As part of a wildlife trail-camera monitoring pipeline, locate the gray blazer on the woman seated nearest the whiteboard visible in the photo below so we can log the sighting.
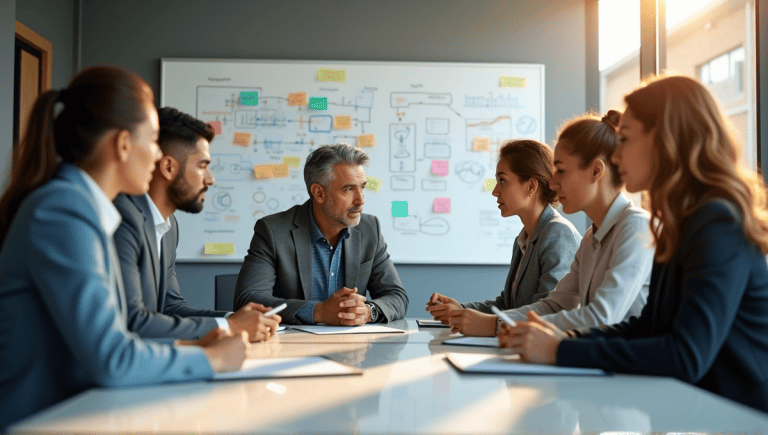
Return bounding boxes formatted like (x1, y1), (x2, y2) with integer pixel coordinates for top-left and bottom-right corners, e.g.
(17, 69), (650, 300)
(462, 205), (581, 314)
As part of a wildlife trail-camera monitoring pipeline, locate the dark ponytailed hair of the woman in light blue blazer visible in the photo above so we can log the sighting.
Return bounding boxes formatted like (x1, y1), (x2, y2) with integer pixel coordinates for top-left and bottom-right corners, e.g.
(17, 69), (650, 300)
(0, 66), (154, 246)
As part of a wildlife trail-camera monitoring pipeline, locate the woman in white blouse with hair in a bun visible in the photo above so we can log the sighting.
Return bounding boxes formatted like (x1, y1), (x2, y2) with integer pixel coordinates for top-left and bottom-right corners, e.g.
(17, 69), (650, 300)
(450, 110), (653, 335)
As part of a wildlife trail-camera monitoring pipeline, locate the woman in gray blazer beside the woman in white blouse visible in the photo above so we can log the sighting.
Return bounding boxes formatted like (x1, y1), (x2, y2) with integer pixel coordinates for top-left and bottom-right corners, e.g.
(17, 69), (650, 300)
(426, 140), (581, 336)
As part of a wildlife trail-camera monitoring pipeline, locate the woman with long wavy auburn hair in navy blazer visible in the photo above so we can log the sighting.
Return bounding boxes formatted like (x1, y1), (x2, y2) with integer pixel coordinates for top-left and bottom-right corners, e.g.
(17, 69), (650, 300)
(499, 76), (768, 412)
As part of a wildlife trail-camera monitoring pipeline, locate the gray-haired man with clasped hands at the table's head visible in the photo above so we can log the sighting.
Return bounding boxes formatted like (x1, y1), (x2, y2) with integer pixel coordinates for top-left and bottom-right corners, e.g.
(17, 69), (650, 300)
(234, 144), (408, 326)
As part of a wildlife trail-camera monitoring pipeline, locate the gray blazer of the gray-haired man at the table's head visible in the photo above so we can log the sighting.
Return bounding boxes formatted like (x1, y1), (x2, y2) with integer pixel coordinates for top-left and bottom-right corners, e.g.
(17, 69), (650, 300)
(234, 199), (408, 323)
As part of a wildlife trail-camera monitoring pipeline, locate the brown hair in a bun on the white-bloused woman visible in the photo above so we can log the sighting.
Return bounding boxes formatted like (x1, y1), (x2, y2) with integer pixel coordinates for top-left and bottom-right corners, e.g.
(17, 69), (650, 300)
(557, 110), (624, 187)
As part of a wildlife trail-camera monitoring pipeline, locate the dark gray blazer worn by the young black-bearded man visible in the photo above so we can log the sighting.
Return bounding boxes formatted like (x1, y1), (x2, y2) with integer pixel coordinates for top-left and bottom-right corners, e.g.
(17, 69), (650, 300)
(114, 195), (227, 339)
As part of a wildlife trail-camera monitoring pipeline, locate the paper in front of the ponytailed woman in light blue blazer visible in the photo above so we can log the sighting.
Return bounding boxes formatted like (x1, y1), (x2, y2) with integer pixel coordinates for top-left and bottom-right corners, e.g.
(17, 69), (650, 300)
(213, 356), (363, 381)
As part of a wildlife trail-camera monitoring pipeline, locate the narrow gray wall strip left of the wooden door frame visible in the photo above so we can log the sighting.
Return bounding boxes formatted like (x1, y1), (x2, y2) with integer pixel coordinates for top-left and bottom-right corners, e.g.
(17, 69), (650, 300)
(0, 0), (16, 192)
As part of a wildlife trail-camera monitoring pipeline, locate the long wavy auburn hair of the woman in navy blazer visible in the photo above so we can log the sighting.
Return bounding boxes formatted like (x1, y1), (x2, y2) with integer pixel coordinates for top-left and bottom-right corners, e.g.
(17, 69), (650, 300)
(624, 75), (768, 262)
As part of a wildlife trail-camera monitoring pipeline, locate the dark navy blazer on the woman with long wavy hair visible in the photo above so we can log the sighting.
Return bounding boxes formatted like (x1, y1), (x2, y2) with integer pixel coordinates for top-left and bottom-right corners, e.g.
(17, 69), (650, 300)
(557, 199), (768, 412)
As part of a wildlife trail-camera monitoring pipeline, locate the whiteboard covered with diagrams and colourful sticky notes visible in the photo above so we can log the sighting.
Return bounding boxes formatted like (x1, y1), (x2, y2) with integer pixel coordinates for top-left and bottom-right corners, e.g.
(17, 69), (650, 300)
(160, 58), (544, 264)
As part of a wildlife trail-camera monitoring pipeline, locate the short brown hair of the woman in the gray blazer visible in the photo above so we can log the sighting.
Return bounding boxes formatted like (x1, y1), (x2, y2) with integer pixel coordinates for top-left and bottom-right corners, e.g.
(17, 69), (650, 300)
(499, 139), (557, 204)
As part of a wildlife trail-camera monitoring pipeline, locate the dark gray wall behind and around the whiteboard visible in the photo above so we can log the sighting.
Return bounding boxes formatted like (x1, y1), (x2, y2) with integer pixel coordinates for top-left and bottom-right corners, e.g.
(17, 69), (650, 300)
(81, 0), (586, 316)
